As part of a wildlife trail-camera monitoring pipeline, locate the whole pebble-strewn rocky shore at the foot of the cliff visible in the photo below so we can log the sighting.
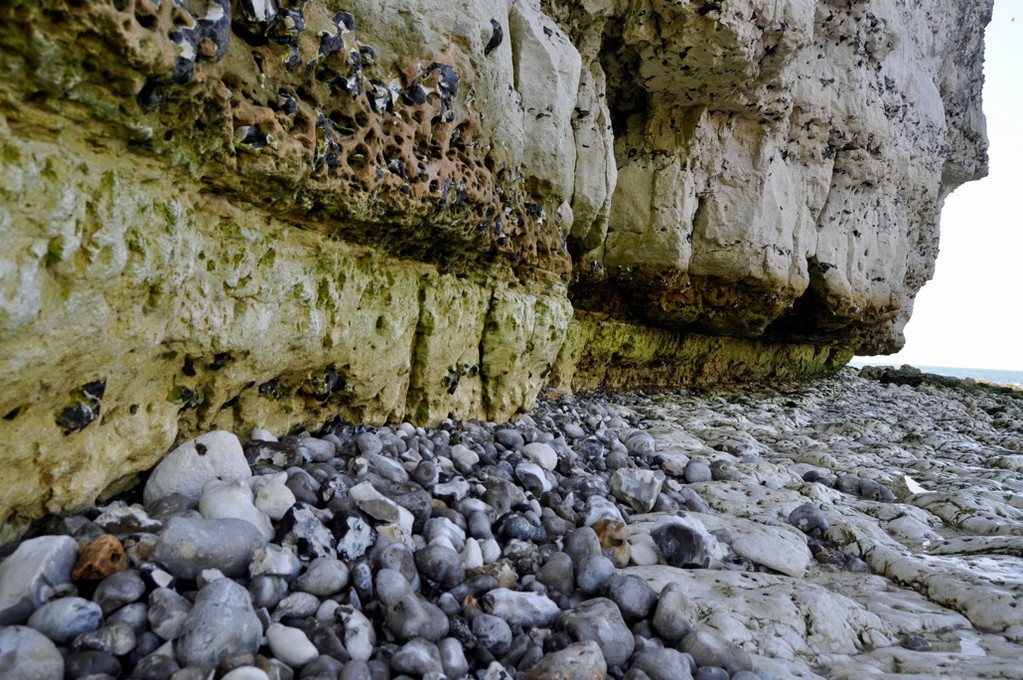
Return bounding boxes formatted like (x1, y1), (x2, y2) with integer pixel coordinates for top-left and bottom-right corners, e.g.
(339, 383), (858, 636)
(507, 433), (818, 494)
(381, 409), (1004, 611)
(0, 369), (1023, 680)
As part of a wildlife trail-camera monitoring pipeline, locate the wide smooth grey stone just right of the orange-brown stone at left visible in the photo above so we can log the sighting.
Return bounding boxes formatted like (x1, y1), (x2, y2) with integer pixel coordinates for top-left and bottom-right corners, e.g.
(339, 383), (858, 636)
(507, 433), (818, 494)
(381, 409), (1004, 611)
(151, 517), (265, 580)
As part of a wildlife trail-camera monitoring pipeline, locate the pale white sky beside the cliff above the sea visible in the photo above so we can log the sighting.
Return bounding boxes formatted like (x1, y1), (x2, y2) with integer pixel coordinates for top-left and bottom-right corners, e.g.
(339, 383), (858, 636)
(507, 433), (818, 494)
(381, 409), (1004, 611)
(857, 0), (1023, 370)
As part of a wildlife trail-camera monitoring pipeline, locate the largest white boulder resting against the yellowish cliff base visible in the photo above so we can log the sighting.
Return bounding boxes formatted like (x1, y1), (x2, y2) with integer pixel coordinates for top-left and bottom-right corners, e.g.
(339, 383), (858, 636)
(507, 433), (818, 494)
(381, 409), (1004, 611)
(142, 429), (251, 507)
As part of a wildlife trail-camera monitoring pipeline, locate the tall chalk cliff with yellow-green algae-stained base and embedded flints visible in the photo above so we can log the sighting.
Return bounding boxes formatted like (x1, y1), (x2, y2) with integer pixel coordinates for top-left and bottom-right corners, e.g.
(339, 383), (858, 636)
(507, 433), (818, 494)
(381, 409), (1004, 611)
(0, 0), (991, 539)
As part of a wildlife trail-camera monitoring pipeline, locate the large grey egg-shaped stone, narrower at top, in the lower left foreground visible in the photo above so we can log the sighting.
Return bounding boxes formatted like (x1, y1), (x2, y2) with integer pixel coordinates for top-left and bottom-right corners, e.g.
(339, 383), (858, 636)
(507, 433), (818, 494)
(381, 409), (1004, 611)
(174, 579), (263, 668)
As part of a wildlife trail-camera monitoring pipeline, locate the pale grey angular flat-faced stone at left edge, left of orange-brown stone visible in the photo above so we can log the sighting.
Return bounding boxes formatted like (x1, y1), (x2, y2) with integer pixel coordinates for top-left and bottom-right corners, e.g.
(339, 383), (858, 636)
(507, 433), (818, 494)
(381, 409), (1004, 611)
(0, 536), (78, 625)
